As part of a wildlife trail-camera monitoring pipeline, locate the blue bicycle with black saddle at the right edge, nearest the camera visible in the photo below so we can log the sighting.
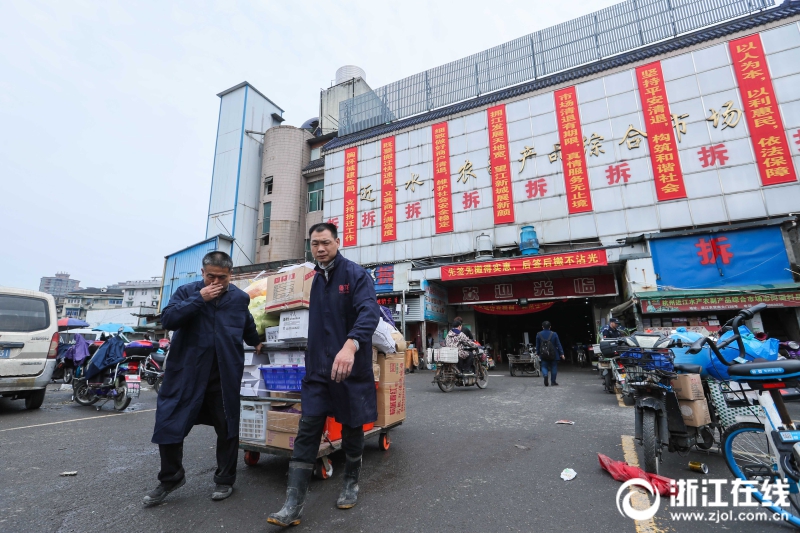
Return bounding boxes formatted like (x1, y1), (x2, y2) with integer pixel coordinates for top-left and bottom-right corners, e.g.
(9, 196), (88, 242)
(688, 304), (800, 528)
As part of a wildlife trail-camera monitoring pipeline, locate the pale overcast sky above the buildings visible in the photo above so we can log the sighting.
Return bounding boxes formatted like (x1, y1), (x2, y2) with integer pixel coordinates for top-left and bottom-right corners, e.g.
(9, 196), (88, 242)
(0, 0), (616, 289)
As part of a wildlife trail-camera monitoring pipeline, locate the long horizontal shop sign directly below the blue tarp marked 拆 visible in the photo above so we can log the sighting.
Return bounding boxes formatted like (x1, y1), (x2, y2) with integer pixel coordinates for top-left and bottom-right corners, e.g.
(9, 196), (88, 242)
(636, 283), (800, 314)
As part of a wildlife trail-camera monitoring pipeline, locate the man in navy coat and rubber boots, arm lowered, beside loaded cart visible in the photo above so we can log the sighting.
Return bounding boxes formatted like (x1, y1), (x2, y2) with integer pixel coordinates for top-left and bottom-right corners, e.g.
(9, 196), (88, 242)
(267, 223), (380, 527)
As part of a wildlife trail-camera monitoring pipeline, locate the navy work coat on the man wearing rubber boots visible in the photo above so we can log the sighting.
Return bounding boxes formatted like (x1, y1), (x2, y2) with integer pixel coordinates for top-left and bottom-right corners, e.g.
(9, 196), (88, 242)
(302, 254), (380, 427)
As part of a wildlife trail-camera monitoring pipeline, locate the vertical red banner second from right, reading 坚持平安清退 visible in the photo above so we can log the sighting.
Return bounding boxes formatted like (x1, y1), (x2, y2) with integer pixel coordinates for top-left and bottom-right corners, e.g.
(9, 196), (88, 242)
(636, 61), (686, 202)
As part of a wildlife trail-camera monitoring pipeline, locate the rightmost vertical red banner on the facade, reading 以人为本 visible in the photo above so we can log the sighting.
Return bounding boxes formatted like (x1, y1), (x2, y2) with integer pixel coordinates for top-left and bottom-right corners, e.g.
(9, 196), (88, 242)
(728, 34), (797, 186)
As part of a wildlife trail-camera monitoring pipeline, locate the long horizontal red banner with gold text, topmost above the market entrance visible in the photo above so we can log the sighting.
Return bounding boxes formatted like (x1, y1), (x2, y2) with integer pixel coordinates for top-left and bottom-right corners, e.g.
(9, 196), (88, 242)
(442, 250), (608, 281)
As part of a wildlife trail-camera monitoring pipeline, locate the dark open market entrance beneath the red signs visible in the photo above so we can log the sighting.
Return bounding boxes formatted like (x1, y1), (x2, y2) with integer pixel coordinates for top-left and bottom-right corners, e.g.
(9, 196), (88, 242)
(475, 298), (596, 361)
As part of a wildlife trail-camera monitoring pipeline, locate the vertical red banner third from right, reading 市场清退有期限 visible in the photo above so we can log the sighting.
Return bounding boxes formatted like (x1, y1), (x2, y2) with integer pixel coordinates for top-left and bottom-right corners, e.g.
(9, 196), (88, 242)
(555, 86), (592, 215)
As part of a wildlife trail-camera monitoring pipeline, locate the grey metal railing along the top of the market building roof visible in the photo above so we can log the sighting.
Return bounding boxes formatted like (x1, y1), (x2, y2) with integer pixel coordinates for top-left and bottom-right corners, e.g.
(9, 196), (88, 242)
(339, 0), (775, 137)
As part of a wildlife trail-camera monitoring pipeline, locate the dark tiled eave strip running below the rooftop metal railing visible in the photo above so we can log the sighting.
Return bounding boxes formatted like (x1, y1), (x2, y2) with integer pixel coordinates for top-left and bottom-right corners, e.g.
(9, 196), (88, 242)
(323, 0), (800, 153)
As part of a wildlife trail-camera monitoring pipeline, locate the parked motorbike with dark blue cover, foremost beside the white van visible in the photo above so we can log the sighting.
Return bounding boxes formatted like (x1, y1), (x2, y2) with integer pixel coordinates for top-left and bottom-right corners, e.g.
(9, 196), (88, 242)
(72, 335), (141, 411)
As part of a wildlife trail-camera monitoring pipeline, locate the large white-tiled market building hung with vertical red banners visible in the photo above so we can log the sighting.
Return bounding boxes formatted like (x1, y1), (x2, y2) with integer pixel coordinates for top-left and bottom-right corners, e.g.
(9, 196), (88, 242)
(322, 0), (800, 353)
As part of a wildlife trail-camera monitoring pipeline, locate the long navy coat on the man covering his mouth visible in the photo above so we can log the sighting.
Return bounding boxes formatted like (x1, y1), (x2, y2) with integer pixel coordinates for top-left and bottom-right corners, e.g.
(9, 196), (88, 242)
(152, 281), (260, 444)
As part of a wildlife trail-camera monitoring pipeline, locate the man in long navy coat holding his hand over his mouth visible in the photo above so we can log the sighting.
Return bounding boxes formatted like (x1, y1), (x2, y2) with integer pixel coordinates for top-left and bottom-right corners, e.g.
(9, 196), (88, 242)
(144, 252), (261, 504)
